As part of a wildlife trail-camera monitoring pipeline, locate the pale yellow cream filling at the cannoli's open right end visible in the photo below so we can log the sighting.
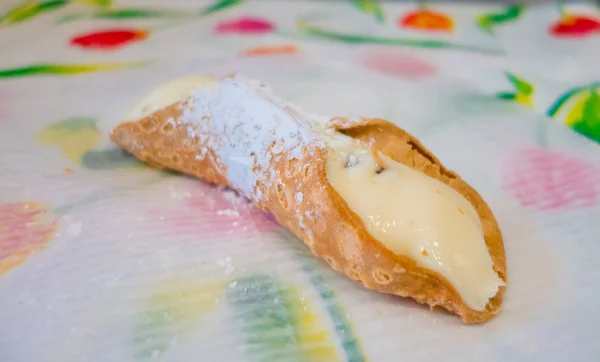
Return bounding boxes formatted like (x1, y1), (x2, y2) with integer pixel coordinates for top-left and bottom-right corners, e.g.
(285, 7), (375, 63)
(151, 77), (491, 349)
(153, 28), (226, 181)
(327, 137), (504, 311)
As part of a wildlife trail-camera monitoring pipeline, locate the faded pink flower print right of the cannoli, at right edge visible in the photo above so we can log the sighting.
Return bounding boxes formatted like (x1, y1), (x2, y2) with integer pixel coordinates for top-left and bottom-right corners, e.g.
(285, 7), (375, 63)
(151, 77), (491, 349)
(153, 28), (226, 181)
(502, 148), (600, 210)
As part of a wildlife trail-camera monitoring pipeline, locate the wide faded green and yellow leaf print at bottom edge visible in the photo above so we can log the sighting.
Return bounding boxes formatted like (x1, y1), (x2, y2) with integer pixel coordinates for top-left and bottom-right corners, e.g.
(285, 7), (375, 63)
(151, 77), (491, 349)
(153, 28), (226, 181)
(227, 275), (339, 362)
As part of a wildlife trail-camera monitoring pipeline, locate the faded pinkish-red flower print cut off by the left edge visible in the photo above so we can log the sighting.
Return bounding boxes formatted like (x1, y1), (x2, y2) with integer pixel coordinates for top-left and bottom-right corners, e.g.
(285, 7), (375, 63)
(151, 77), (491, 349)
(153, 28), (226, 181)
(0, 202), (58, 275)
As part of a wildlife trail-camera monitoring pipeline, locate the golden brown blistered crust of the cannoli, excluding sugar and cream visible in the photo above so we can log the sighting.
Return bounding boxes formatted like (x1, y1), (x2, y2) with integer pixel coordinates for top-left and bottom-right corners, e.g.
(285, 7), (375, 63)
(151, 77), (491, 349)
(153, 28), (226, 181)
(111, 104), (506, 323)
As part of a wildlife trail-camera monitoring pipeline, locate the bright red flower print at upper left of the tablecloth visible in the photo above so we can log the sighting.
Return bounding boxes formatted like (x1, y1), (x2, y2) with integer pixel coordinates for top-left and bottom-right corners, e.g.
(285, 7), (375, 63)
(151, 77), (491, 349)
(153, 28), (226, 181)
(71, 29), (150, 50)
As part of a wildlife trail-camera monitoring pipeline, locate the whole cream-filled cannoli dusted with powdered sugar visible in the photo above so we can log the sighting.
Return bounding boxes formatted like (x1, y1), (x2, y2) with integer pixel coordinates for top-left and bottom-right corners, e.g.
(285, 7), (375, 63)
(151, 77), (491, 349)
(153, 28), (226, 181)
(111, 75), (506, 323)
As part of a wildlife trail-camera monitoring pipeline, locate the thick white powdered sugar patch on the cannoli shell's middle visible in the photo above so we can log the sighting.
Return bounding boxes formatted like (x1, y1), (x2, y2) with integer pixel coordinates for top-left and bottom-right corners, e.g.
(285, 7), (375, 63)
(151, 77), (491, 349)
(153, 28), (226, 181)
(179, 76), (329, 202)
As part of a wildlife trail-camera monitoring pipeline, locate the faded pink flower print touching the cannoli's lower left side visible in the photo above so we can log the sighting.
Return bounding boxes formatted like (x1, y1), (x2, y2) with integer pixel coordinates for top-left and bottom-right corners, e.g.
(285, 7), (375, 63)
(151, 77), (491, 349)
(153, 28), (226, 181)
(152, 182), (278, 237)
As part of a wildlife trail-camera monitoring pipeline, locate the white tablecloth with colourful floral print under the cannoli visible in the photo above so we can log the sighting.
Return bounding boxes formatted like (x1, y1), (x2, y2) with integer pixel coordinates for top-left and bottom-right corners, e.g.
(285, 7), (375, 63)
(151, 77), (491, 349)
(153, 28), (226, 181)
(0, 0), (600, 362)
